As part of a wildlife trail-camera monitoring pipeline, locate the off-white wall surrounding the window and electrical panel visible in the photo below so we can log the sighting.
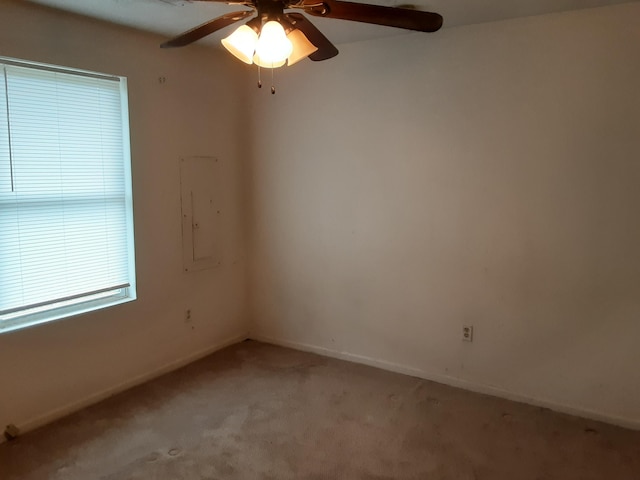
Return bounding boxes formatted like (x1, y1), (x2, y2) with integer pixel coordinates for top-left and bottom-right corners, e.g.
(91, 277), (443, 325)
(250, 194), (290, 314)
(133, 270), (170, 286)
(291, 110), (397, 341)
(0, 0), (247, 436)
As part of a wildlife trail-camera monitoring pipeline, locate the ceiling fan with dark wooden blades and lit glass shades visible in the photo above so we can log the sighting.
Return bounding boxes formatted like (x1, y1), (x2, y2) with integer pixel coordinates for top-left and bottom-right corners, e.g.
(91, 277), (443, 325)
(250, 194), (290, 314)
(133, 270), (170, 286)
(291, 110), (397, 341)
(160, 0), (442, 71)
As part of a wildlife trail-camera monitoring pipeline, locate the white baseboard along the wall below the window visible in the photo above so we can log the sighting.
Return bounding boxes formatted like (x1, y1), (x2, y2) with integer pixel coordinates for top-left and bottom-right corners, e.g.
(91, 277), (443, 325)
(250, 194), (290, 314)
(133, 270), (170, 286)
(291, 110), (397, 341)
(5, 334), (247, 443)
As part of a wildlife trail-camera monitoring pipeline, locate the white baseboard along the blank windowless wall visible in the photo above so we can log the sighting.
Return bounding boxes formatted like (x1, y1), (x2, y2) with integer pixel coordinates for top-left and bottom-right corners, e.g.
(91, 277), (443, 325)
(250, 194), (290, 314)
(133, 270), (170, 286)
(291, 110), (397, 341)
(249, 334), (640, 430)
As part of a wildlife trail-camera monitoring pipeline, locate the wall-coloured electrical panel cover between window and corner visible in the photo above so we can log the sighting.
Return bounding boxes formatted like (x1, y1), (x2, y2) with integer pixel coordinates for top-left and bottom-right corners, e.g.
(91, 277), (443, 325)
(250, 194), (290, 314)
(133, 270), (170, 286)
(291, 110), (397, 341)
(180, 157), (222, 272)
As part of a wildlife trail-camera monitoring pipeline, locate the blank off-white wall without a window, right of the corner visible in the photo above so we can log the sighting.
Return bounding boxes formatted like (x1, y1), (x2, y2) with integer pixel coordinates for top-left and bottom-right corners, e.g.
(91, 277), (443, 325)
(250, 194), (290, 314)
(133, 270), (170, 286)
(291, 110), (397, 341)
(250, 3), (640, 428)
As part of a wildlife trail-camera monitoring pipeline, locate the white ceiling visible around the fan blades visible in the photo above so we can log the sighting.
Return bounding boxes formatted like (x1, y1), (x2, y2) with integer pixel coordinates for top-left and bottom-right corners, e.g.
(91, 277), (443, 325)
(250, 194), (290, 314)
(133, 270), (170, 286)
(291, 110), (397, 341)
(30, 0), (629, 45)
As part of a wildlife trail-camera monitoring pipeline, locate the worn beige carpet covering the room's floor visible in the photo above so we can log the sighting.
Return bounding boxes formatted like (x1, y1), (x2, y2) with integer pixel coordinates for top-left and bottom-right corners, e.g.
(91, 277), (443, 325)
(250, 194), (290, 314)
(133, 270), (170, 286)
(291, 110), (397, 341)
(0, 341), (640, 480)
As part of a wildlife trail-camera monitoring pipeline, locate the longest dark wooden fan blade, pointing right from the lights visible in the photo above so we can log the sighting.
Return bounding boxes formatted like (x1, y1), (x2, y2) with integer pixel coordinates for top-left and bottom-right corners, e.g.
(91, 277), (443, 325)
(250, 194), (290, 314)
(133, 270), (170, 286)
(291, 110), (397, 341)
(302, 0), (442, 32)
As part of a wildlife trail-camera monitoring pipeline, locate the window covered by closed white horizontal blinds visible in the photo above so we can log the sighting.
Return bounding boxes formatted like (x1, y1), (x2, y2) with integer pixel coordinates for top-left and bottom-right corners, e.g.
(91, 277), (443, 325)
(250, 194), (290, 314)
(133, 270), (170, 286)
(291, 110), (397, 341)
(0, 57), (135, 332)
